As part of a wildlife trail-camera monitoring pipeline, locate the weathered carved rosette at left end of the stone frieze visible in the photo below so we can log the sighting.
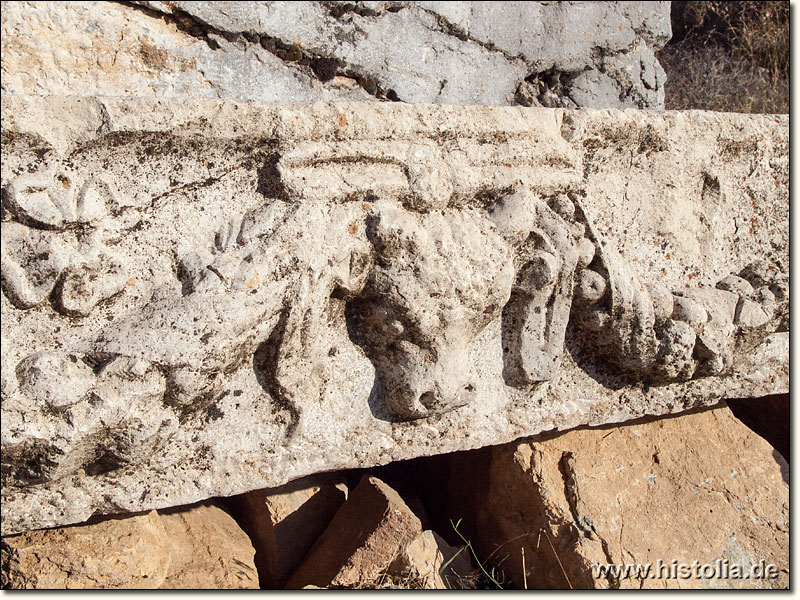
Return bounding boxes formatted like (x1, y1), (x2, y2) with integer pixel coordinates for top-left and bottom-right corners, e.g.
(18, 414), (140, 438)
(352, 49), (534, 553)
(2, 160), (128, 316)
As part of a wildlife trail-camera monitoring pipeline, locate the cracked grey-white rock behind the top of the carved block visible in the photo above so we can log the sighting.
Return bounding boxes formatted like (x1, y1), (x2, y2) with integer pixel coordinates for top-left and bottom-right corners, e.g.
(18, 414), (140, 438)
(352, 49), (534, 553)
(2, 2), (671, 108)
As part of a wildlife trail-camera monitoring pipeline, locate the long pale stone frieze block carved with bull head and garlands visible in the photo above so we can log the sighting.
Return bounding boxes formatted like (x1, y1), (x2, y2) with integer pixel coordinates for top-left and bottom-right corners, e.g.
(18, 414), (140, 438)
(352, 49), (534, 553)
(0, 94), (789, 535)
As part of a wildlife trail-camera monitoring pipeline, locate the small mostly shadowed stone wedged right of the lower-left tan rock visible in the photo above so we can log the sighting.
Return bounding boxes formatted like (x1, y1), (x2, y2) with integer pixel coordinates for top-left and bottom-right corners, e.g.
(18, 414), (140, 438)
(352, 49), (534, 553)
(232, 473), (348, 589)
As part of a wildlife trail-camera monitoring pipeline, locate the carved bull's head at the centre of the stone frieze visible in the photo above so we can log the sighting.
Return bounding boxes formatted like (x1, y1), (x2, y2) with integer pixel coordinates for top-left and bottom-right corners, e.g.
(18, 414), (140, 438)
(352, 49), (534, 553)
(348, 201), (514, 418)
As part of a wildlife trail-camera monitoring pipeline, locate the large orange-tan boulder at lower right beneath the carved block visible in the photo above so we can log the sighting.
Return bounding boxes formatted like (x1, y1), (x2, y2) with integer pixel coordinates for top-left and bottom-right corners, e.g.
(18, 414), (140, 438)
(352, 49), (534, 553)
(451, 404), (789, 589)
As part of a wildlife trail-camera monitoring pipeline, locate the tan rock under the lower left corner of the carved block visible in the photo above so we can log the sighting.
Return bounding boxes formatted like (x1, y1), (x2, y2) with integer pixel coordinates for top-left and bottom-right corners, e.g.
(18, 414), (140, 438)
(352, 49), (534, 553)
(2, 504), (258, 589)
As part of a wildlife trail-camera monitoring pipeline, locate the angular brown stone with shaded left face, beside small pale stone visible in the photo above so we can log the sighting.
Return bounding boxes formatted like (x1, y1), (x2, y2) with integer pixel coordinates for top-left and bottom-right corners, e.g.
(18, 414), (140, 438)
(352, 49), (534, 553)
(287, 475), (422, 589)
